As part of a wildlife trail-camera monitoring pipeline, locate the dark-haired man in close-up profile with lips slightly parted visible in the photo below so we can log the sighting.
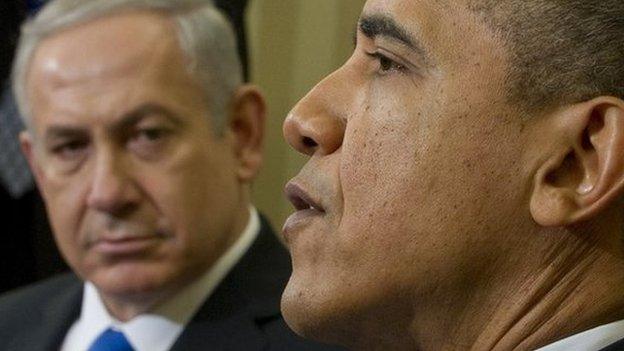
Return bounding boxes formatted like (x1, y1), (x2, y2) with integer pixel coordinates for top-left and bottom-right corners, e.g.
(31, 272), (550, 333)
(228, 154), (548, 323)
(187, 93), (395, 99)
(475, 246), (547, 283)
(282, 0), (624, 351)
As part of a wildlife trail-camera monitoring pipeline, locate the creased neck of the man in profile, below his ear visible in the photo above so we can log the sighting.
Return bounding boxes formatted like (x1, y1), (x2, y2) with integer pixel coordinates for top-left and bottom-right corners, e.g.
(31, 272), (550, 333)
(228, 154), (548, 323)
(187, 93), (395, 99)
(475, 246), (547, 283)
(411, 219), (624, 351)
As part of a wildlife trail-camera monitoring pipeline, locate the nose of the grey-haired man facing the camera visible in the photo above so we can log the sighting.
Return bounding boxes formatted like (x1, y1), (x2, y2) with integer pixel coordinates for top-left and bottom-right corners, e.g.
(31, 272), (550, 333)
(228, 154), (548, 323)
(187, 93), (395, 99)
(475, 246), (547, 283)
(87, 150), (140, 216)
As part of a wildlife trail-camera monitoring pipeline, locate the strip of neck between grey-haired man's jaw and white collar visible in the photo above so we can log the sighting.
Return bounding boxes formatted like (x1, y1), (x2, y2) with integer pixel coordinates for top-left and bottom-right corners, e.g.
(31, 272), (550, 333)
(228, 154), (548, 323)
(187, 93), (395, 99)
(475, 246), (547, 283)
(98, 201), (250, 322)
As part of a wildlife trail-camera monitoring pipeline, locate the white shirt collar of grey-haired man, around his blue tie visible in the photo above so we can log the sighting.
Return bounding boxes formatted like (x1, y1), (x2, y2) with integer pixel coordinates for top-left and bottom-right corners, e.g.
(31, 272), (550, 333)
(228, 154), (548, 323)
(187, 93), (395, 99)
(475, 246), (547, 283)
(61, 207), (260, 351)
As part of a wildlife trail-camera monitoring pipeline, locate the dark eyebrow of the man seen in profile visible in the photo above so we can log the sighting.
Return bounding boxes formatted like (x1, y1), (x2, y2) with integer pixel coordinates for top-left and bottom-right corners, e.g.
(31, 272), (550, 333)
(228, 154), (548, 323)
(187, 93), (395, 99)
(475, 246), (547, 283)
(358, 14), (431, 64)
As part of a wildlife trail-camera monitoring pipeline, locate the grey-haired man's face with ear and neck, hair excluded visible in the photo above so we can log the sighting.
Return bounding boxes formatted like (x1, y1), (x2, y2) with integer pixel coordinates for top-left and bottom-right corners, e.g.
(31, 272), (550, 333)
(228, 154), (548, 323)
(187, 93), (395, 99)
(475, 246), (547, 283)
(21, 12), (264, 320)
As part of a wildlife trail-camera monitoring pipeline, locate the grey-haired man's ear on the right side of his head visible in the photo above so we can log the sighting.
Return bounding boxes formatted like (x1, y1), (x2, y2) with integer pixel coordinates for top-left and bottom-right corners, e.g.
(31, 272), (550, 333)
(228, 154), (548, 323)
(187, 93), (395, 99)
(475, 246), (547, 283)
(228, 85), (266, 183)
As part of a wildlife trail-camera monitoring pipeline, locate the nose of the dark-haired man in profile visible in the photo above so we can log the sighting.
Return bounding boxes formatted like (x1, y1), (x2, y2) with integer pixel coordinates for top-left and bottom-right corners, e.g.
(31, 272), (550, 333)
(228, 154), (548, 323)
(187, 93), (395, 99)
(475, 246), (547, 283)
(283, 70), (352, 156)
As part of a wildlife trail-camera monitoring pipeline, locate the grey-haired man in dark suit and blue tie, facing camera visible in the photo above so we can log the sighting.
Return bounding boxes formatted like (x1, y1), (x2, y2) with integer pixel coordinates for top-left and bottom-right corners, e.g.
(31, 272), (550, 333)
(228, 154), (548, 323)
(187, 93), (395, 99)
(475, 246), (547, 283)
(0, 0), (342, 351)
